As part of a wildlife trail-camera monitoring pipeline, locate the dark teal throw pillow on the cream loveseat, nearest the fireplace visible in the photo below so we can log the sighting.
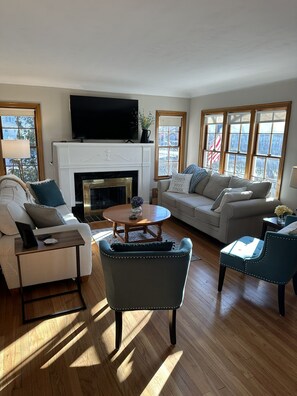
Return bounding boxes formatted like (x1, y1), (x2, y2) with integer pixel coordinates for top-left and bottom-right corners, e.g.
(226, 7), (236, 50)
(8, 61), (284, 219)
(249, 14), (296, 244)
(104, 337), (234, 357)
(27, 179), (65, 207)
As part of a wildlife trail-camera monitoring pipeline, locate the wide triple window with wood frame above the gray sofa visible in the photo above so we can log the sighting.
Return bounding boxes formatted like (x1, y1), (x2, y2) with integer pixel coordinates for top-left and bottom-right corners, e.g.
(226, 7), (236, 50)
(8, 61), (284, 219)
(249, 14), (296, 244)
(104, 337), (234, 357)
(199, 102), (291, 197)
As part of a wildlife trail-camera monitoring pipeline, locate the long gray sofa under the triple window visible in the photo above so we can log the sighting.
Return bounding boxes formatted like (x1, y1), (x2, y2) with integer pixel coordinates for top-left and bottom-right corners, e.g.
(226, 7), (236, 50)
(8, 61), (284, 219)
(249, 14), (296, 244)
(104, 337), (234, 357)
(157, 172), (280, 243)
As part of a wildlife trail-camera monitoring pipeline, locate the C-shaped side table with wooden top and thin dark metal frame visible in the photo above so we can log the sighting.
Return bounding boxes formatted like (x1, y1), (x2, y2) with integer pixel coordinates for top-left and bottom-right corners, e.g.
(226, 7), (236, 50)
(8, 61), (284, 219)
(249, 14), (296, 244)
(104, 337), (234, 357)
(15, 230), (86, 323)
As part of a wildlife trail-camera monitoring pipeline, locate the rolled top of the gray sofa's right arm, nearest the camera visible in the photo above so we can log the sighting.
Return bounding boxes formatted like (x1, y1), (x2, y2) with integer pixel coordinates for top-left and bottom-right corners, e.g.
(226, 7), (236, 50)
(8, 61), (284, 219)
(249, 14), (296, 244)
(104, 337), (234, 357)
(221, 198), (280, 221)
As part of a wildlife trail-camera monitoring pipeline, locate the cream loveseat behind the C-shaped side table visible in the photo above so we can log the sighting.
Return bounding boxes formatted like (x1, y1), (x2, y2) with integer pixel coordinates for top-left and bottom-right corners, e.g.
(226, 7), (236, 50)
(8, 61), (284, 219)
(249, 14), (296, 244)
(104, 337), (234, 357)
(0, 176), (92, 289)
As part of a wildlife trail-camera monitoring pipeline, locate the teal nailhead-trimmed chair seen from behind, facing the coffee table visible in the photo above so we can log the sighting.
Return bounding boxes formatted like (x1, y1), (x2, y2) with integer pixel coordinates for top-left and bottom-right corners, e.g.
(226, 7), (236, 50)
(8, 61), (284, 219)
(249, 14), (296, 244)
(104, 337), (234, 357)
(99, 238), (192, 349)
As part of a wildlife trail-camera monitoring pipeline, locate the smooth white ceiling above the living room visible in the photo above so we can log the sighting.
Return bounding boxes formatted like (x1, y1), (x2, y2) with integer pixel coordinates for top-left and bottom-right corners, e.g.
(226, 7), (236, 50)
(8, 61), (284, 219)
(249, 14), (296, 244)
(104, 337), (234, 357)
(0, 0), (297, 97)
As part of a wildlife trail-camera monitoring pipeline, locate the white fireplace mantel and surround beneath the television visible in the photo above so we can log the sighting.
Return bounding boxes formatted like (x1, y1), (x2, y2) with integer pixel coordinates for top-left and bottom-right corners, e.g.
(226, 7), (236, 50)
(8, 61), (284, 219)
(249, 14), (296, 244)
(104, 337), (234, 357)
(53, 142), (153, 208)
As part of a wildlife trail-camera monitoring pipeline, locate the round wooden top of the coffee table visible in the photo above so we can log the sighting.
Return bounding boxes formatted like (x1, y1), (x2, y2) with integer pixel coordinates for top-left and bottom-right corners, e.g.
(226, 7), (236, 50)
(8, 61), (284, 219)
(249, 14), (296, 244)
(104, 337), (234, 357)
(103, 204), (171, 226)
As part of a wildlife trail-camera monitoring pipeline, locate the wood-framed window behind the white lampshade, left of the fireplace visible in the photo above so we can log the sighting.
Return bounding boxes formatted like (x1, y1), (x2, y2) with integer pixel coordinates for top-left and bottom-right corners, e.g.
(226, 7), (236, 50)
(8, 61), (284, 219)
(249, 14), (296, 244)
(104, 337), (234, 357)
(0, 102), (44, 181)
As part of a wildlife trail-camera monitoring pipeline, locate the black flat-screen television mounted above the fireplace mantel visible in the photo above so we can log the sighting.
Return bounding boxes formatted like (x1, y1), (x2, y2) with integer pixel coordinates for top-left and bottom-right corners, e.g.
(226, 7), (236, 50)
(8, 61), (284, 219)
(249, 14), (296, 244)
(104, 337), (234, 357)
(70, 95), (138, 141)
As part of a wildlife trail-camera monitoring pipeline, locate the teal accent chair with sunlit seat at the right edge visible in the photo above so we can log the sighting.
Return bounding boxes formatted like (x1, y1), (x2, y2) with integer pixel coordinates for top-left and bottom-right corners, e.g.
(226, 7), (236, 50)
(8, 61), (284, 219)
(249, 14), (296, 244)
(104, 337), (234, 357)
(218, 216), (297, 316)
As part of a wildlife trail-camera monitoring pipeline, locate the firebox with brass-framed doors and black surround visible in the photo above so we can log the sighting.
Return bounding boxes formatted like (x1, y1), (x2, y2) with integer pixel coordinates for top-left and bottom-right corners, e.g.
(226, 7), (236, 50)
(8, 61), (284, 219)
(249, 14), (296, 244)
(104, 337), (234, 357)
(73, 171), (138, 218)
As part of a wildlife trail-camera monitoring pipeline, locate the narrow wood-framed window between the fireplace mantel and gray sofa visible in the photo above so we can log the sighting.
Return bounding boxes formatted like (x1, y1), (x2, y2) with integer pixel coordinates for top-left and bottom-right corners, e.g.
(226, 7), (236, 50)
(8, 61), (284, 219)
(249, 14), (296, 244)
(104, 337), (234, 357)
(155, 111), (186, 180)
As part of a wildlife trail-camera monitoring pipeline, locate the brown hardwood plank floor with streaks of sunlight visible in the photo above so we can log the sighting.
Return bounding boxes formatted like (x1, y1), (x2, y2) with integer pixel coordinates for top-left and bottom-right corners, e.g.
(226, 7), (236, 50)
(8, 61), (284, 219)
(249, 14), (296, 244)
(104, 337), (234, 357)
(0, 220), (297, 396)
